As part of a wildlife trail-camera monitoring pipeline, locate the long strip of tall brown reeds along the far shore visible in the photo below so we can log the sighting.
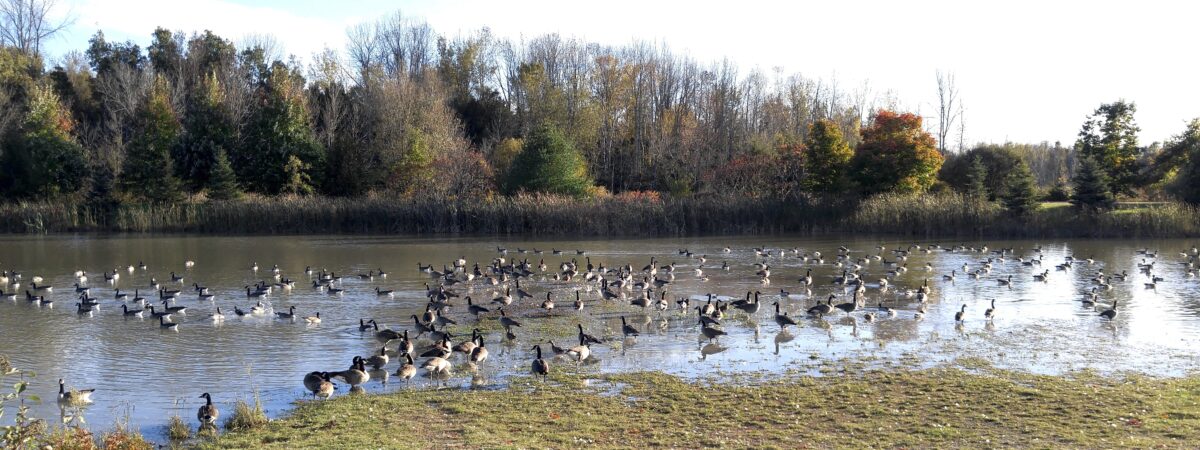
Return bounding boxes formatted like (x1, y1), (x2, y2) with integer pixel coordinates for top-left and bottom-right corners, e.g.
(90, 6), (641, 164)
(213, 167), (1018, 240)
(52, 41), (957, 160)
(0, 194), (1200, 238)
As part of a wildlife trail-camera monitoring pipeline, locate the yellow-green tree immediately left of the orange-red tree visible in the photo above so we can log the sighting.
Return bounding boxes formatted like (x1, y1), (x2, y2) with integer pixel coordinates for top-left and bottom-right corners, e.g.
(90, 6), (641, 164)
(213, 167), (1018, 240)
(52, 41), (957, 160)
(804, 119), (854, 192)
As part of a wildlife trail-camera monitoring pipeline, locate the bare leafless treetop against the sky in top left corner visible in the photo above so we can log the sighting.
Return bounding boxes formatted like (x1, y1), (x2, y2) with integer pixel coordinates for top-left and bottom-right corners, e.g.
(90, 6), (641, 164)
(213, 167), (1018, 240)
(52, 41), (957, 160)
(0, 0), (73, 54)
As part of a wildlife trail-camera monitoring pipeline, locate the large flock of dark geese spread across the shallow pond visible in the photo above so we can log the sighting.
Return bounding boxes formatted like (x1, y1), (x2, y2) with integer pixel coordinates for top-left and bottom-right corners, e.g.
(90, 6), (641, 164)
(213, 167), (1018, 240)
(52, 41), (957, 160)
(11, 244), (1200, 427)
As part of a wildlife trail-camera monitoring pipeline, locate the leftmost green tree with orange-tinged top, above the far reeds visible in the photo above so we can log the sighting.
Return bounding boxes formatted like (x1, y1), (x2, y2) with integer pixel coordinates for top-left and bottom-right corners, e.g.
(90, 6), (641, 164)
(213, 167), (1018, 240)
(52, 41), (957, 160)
(0, 85), (88, 198)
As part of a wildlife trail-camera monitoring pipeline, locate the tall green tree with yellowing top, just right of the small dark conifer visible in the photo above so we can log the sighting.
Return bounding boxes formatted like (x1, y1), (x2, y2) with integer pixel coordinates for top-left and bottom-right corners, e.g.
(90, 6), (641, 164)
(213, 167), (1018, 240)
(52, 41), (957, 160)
(229, 62), (325, 194)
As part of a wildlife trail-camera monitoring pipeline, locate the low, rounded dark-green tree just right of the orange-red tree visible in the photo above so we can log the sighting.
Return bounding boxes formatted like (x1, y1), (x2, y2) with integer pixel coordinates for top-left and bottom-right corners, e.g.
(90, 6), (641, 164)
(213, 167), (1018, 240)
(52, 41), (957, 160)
(937, 144), (1022, 199)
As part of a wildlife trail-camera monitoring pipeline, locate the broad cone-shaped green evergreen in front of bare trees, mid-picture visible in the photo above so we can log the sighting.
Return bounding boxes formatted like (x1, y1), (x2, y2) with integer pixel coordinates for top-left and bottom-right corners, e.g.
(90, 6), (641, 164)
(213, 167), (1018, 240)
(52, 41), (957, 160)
(505, 125), (592, 197)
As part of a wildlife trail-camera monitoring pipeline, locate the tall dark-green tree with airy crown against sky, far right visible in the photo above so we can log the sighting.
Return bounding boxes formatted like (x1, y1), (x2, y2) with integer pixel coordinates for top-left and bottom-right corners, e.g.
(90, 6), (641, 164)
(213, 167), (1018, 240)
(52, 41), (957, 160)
(1075, 100), (1141, 196)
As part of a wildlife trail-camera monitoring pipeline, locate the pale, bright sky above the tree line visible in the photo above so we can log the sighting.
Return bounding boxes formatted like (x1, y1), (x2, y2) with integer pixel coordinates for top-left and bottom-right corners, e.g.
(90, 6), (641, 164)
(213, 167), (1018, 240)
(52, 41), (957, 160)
(37, 0), (1200, 144)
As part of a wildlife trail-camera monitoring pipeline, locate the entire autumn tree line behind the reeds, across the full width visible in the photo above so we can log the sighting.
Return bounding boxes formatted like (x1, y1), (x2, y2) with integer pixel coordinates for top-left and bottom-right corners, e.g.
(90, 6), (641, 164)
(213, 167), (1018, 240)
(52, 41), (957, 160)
(0, 5), (1200, 214)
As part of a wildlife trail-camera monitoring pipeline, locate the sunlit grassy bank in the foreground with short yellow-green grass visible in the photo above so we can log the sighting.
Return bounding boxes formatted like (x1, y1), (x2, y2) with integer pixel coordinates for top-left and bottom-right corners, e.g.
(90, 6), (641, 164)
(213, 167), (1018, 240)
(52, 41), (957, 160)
(194, 368), (1200, 449)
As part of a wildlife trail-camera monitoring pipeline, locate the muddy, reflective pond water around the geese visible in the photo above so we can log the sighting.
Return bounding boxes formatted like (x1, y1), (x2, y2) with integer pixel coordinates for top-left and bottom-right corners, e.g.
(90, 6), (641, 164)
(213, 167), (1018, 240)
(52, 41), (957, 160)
(0, 235), (1200, 439)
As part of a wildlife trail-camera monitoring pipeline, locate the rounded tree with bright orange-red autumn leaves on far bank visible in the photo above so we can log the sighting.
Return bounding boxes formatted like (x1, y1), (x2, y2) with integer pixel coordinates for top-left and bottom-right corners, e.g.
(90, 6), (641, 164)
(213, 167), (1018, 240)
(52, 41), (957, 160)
(853, 109), (943, 193)
